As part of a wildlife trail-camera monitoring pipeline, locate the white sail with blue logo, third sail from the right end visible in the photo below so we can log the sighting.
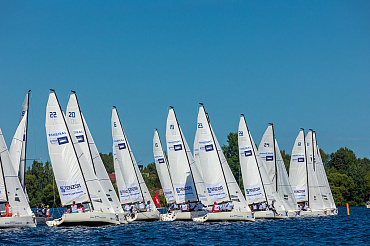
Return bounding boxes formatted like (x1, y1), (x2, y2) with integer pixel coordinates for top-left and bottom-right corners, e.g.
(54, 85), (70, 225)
(289, 130), (308, 202)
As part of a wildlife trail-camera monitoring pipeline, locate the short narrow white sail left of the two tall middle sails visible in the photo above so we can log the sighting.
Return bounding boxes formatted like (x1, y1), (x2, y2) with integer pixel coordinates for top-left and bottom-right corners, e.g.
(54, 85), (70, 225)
(153, 130), (175, 203)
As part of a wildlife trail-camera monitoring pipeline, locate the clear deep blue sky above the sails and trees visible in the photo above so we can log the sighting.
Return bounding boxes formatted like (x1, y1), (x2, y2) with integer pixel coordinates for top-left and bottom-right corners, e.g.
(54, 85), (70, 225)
(0, 0), (370, 168)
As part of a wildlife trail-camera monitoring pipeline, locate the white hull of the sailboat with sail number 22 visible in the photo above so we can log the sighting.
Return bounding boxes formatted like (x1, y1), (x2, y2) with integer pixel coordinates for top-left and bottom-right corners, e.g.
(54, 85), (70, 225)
(46, 212), (120, 226)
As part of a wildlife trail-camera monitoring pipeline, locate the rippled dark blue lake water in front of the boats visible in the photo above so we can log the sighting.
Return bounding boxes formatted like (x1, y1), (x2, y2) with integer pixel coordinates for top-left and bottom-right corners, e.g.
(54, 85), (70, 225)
(0, 207), (370, 246)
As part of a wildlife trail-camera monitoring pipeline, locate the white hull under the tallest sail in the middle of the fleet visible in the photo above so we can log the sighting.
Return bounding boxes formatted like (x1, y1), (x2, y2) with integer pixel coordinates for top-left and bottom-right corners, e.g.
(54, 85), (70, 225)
(193, 211), (255, 222)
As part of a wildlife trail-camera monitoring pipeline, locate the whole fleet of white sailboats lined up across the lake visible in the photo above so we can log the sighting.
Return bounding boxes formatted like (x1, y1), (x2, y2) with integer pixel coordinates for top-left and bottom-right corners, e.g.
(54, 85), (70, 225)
(0, 90), (338, 228)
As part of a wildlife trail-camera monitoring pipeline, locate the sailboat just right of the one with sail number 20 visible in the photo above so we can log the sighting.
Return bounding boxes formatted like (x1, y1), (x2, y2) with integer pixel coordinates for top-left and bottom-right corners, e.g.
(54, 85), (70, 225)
(111, 107), (159, 220)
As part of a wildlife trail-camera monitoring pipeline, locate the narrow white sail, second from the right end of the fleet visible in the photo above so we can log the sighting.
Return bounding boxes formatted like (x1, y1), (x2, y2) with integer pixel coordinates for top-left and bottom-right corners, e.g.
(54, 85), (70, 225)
(305, 131), (325, 209)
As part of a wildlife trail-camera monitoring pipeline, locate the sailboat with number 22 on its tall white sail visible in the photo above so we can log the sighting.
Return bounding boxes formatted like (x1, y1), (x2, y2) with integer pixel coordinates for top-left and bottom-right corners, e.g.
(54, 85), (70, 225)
(45, 90), (120, 226)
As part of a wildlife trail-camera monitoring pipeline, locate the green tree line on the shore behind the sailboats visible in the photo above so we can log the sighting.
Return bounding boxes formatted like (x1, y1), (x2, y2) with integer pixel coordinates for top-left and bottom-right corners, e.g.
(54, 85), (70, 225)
(25, 132), (370, 207)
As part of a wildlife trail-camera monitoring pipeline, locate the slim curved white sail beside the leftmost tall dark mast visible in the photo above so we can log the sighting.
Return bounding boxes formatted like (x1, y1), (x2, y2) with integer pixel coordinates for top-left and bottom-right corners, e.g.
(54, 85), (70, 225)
(9, 111), (27, 174)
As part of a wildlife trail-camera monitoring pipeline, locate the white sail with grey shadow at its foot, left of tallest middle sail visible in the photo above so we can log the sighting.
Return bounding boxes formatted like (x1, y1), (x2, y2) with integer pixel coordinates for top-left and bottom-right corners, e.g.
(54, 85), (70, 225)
(166, 107), (209, 205)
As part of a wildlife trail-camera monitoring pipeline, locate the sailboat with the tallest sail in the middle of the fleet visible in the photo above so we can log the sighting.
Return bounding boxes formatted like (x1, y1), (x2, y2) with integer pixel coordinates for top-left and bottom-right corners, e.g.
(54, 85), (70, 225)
(191, 104), (254, 222)
